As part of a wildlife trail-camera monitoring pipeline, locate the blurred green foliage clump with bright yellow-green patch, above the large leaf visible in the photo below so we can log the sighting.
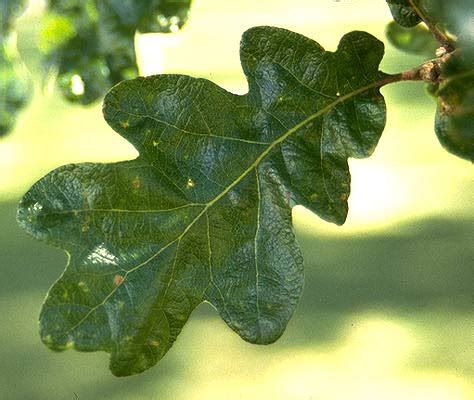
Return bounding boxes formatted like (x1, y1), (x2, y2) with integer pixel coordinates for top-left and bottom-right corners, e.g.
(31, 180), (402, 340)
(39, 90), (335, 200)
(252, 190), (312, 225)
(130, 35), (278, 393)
(40, 0), (191, 105)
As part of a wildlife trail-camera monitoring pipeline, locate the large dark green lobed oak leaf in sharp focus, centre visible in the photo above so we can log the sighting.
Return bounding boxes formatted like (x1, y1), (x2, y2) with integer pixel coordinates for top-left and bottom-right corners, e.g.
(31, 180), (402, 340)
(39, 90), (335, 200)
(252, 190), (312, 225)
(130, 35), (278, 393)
(18, 27), (388, 376)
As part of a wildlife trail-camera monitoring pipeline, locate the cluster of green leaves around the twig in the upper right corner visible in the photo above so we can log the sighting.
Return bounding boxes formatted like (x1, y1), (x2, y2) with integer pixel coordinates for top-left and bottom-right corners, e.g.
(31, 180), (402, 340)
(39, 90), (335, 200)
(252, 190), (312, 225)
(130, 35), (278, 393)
(386, 0), (474, 161)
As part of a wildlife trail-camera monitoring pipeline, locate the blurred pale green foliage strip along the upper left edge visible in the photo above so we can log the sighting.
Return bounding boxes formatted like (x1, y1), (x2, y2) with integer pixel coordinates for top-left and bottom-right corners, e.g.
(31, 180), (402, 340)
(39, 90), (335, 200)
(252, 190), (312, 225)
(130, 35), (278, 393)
(0, 0), (32, 137)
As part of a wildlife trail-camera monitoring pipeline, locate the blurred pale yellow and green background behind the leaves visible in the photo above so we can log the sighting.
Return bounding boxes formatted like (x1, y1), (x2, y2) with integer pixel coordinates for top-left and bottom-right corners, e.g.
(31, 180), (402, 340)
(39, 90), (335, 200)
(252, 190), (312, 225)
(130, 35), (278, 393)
(0, 0), (474, 400)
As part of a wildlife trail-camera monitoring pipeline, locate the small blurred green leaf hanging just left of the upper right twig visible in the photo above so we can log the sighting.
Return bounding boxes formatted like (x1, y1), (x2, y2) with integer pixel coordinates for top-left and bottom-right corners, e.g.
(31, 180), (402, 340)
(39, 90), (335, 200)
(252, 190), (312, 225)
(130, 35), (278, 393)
(385, 21), (440, 58)
